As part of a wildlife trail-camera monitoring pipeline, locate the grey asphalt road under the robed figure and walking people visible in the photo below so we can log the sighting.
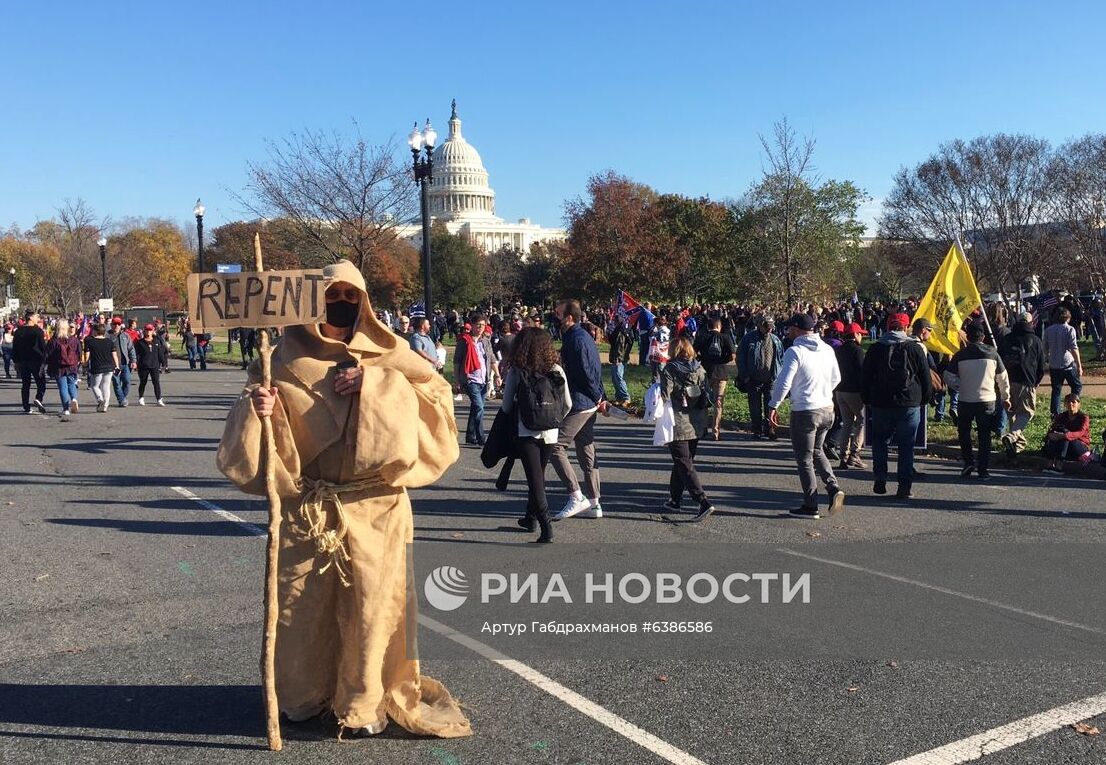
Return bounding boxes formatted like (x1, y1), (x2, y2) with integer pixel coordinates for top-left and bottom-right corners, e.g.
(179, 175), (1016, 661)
(0, 369), (1106, 765)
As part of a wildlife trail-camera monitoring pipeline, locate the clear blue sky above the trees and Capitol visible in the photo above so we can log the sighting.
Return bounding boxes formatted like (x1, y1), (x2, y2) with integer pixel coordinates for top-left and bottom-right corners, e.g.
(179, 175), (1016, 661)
(0, 0), (1106, 236)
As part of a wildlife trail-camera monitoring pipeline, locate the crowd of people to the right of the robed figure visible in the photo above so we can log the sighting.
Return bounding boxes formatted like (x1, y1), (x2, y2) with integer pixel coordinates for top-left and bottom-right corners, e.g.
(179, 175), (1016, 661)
(413, 297), (1106, 542)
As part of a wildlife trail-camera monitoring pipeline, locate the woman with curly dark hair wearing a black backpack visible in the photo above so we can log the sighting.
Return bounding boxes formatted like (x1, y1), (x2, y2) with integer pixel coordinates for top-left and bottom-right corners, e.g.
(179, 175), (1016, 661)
(502, 327), (572, 542)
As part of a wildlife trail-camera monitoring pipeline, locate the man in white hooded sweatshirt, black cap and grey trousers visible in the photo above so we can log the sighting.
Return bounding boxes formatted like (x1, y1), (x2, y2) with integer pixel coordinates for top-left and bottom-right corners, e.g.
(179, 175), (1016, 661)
(768, 314), (845, 518)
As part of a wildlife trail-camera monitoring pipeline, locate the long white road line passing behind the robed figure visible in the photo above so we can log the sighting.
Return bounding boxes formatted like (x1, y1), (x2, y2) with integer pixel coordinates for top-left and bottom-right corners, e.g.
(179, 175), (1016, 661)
(171, 486), (707, 765)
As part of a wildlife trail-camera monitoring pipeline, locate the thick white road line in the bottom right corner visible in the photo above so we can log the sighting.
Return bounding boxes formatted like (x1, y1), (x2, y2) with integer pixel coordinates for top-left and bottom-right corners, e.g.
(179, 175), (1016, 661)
(890, 693), (1106, 765)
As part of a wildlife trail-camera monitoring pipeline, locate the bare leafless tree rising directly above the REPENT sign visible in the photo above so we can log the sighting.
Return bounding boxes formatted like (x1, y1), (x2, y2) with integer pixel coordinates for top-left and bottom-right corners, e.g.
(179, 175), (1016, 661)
(232, 124), (417, 272)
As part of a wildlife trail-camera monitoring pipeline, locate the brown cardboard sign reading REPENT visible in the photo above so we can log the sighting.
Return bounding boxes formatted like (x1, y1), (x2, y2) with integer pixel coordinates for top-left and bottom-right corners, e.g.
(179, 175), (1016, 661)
(188, 270), (326, 329)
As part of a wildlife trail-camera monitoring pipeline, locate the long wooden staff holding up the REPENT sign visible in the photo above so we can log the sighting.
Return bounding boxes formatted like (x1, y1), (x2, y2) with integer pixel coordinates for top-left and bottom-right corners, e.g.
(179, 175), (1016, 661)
(253, 233), (284, 752)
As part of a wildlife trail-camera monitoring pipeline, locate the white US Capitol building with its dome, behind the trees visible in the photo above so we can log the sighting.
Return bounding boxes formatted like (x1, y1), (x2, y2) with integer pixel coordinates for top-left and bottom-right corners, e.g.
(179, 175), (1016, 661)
(399, 101), (567, 255)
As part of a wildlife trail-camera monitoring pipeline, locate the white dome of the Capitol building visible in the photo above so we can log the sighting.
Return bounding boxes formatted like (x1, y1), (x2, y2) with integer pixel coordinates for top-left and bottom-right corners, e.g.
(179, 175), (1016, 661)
(429, 101), (495, 220)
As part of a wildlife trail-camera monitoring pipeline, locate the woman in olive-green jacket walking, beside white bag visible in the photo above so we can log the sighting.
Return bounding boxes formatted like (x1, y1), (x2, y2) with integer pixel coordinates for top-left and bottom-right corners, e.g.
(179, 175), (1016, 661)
(660, 337), (714, 521)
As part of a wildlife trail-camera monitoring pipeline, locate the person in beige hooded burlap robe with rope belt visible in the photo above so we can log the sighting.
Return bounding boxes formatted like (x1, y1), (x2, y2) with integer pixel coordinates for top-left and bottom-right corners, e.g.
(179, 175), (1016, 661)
(217, 261), (472, 737)
